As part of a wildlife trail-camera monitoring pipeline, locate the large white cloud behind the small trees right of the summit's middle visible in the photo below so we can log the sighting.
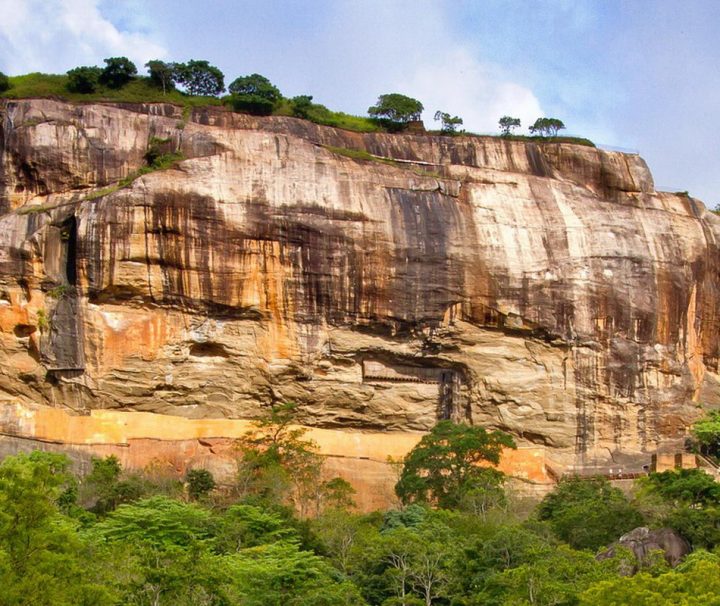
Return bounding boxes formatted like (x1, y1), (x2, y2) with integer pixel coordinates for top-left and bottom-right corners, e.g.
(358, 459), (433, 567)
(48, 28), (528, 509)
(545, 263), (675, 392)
(266, 0), (543, 133)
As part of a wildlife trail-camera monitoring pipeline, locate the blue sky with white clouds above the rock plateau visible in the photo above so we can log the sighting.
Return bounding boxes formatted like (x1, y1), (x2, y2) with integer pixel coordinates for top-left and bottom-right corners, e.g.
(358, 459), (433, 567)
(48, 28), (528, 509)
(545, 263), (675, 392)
(0, 0), (720, 208)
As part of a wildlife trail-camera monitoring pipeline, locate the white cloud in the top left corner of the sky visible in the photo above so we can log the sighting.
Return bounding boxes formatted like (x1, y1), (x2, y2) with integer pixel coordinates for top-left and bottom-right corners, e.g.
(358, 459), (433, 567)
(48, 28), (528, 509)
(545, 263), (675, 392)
(0, 0), (167, 75)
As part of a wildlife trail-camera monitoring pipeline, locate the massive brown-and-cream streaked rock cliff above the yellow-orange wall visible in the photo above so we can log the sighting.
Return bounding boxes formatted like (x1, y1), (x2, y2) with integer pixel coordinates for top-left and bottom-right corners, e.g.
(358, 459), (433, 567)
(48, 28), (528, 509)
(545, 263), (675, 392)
(0, 100), (720, 478)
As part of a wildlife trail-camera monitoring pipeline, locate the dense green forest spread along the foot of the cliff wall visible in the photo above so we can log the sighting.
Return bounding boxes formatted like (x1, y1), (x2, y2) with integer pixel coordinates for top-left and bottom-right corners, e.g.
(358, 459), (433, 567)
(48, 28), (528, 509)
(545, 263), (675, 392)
(0, 406), (720, 606)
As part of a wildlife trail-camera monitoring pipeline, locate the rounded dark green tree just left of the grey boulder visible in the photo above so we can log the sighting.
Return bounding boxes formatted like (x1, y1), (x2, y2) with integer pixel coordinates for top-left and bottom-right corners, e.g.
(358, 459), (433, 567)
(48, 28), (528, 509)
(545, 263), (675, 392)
(537, 476), (644, 550)
